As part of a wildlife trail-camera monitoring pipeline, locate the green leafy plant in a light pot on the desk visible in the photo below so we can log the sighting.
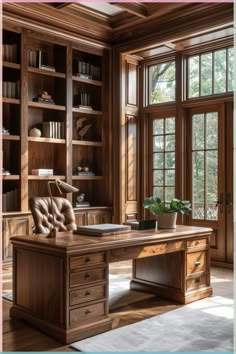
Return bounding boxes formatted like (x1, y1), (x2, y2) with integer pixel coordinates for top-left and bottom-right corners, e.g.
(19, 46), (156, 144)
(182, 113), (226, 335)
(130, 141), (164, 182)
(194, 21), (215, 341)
(143, 196), (192, 229)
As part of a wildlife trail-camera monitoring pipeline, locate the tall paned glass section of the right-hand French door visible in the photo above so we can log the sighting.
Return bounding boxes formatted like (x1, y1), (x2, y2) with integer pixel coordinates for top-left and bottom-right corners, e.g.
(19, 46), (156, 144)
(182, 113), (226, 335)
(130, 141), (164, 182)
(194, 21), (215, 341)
(192, 112), (218, 220)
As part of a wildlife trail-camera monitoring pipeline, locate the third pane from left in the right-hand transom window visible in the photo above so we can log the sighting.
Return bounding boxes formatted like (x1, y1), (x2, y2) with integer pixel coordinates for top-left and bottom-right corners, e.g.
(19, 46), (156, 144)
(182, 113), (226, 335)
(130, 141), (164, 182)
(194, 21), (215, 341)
(214, 49), (226, 93)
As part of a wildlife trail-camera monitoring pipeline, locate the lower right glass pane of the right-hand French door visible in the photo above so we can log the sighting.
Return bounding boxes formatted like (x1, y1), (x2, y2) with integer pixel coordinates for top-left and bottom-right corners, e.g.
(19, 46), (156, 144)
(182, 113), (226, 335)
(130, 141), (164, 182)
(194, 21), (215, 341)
(205, 151), (218, 220)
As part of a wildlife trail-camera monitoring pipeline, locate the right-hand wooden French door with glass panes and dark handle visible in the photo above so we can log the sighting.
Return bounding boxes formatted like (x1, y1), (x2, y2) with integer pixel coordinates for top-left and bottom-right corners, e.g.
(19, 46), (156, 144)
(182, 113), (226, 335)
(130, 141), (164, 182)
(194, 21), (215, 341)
(186, 104), (233, 262)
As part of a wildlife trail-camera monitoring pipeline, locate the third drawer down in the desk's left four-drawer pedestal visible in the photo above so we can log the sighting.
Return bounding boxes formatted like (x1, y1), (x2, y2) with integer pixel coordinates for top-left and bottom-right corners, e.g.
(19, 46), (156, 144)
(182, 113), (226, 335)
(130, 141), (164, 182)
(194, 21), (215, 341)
(70, 285), (106, 306)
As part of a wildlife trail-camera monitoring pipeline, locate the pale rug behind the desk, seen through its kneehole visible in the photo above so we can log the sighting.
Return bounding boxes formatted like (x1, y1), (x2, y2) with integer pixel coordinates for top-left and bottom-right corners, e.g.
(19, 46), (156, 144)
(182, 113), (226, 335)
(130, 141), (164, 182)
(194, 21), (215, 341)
(2, 274), (154, 311)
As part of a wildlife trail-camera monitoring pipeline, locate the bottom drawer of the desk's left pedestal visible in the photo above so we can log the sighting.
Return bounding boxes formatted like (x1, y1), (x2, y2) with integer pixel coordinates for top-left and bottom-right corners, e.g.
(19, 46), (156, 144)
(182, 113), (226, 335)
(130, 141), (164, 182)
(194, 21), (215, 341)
(70, 301), (106, 326)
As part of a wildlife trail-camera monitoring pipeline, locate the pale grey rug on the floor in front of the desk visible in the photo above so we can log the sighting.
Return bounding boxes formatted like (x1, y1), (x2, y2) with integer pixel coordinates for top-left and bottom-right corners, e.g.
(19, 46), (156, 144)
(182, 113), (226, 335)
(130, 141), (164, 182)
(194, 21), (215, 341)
(71, 296), (233, 352)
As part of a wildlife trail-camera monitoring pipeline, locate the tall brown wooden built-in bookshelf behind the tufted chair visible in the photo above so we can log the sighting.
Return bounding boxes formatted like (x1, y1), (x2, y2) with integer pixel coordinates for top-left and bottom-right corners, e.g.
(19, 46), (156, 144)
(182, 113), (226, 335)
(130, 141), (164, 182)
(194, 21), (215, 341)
(2, 28), (112, 260)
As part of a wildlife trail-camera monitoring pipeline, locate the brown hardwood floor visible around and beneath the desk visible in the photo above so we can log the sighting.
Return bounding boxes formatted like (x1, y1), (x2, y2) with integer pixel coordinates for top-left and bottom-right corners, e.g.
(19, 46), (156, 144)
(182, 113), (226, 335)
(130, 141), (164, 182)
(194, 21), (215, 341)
(2, 261), (233, 352)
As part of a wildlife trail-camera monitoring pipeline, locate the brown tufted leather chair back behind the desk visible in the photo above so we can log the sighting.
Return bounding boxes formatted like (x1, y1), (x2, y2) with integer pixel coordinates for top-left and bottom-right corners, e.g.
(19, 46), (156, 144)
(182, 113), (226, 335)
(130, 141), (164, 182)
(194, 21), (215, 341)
(29, 197), (76, 234)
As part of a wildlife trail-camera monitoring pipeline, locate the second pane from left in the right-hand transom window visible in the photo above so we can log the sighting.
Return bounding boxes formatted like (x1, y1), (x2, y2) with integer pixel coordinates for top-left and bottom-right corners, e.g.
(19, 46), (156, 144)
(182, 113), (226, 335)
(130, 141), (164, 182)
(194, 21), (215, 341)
(201, 53), (212, 96)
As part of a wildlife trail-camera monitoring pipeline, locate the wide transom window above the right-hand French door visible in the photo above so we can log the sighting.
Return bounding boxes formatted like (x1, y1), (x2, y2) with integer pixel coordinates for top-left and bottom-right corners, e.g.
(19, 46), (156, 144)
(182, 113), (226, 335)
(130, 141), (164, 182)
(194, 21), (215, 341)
(187, 48), (234, 98)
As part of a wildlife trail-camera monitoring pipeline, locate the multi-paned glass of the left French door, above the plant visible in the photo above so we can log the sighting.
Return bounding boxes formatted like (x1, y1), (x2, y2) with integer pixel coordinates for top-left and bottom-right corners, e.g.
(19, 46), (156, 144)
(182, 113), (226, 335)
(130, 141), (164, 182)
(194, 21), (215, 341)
(152, 117), (175, 203)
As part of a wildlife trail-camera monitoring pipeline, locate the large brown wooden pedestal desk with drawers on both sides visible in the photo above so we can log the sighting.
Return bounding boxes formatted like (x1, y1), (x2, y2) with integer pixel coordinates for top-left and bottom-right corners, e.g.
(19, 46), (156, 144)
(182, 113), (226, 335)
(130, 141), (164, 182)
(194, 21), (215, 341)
(11, 226), (212, 343)
